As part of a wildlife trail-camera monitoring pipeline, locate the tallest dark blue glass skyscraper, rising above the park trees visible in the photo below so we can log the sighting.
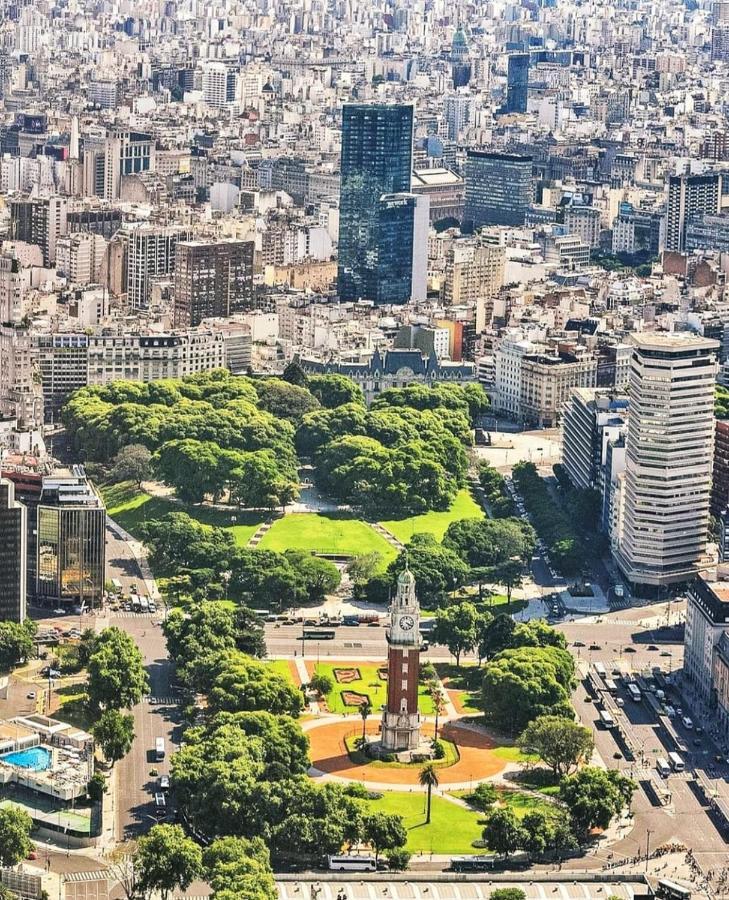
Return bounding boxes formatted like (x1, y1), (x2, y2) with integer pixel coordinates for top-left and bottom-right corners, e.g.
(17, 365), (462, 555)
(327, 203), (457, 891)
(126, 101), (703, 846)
(338, 105), (414, 303)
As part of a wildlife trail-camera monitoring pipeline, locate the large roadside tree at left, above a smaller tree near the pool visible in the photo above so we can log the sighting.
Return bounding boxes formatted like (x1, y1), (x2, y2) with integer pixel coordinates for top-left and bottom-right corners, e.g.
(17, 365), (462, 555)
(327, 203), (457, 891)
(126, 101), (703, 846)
(86, 626), (149, 711)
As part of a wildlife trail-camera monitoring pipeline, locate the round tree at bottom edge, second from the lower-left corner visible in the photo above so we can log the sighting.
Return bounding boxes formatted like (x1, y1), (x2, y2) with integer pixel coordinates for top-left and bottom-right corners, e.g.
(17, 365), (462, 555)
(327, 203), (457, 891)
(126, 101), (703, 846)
(136, 825), (203, 900)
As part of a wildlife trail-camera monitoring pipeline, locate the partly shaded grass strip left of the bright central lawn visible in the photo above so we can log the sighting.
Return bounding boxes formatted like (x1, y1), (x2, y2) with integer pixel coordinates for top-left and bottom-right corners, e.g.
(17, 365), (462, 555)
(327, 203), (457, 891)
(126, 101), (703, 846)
(101, 481), (265, 547)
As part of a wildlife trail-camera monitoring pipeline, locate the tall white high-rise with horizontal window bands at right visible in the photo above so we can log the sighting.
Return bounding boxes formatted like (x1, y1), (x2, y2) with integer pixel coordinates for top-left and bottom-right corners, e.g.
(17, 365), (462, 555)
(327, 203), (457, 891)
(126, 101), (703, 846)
(617, 332), (719, 595)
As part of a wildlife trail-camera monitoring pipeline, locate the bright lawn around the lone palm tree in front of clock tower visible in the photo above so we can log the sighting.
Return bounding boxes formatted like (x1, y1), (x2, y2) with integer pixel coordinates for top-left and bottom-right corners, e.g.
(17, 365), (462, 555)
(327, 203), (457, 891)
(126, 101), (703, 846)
(363, 791), (483, 854)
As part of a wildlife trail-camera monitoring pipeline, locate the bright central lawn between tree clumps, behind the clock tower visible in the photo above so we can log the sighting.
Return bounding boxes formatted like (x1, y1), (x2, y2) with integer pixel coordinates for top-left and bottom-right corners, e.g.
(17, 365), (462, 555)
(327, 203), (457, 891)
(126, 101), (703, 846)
(259, 513), (397, 564)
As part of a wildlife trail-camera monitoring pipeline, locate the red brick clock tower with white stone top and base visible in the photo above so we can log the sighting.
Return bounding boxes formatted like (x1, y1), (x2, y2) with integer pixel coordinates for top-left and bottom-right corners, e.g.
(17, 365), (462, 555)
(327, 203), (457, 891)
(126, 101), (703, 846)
(380, 567), (420, 752)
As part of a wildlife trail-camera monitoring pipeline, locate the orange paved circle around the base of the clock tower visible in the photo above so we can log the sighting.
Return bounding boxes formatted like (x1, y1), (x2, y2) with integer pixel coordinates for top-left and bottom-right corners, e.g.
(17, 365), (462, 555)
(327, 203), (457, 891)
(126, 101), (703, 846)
(303, 717), (507, 790)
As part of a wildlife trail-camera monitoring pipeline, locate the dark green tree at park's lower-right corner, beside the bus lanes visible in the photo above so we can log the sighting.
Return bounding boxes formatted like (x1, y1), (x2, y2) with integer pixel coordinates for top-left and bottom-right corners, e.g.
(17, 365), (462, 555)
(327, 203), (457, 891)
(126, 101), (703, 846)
(559, 766), (636, 840)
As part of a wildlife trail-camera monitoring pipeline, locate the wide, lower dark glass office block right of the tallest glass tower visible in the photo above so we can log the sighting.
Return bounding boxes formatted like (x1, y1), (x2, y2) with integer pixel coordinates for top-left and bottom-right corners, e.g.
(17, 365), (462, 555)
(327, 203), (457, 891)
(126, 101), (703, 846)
(463, 150), (534, 228)
